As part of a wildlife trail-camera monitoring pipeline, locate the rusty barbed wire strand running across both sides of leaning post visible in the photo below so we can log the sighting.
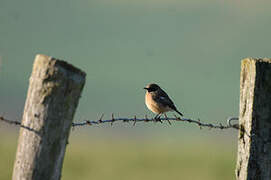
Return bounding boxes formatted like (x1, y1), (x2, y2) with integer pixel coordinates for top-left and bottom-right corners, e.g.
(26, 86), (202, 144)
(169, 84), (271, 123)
(0, 113), (240, 130)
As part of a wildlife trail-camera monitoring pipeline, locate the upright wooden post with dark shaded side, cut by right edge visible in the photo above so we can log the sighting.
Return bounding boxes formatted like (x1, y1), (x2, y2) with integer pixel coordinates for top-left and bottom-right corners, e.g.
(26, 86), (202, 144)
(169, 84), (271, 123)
(236, 59), (271, 180)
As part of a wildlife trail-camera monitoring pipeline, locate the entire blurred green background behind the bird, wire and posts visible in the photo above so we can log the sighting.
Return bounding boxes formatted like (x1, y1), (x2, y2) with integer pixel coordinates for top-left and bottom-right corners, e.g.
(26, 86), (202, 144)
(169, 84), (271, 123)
(0, 0), (271, 180)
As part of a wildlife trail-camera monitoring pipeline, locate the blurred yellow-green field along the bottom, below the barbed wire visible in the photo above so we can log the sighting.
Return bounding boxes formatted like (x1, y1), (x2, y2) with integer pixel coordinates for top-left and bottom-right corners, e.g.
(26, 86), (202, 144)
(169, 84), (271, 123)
(0, 131), (236, 180)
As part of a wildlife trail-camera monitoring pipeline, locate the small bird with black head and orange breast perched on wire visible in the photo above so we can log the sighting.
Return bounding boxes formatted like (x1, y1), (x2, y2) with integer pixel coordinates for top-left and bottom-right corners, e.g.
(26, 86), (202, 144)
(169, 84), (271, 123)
(144, 83), (183, 119)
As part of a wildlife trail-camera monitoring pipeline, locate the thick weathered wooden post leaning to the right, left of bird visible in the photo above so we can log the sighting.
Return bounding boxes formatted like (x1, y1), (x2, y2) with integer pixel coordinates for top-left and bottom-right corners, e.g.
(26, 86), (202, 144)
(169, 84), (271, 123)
(12, 55), (86, 180)
